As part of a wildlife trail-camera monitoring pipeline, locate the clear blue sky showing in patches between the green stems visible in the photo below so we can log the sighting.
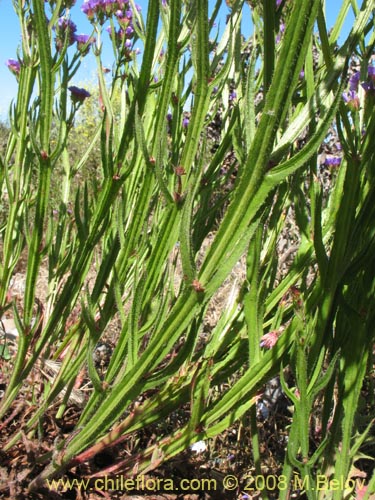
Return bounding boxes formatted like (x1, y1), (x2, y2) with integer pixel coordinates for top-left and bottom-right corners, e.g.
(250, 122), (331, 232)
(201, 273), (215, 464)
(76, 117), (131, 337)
(0, 0), (353, 119)
